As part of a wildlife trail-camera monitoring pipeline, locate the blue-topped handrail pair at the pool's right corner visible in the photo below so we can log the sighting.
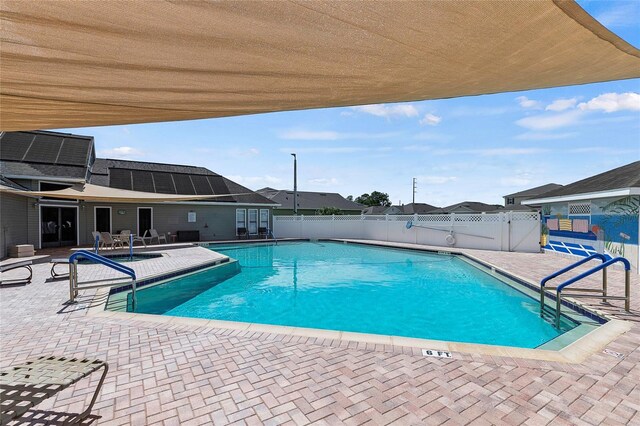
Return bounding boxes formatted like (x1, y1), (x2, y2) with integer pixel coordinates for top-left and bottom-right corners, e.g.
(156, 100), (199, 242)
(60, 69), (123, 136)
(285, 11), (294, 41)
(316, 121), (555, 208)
(540, 253), (631, 328)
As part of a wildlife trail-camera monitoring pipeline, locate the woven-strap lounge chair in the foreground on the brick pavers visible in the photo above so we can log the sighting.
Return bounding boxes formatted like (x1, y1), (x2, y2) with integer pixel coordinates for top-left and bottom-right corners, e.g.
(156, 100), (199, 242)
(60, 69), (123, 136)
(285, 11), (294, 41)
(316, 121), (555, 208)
(0, 356), (109, 425)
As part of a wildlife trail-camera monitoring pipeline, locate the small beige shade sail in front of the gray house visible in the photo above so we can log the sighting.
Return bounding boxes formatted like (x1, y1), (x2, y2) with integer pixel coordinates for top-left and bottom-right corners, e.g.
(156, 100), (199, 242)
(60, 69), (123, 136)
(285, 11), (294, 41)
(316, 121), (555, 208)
(0, 183), (260, 204)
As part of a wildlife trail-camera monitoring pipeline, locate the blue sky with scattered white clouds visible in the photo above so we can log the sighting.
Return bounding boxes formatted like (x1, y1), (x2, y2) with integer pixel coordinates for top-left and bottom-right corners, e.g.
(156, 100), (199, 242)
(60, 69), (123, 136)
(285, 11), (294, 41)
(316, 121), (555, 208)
(59, 0), (640, 207)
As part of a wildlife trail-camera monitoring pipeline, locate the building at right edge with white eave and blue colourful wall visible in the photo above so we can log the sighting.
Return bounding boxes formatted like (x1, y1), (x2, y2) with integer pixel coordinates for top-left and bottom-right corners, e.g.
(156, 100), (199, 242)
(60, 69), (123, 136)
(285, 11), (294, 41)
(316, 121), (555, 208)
(522, 161), (640, 271)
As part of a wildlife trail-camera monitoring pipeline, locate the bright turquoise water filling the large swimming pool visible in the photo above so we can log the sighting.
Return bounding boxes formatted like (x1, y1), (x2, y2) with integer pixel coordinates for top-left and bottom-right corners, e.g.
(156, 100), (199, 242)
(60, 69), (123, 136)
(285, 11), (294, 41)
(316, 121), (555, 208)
(130, 242), (575, 348)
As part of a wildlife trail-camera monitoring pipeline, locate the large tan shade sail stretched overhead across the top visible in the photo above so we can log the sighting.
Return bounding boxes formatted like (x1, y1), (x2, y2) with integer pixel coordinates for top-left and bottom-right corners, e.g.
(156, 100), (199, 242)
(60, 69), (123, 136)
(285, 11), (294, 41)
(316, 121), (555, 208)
(0, 0), (640, 131)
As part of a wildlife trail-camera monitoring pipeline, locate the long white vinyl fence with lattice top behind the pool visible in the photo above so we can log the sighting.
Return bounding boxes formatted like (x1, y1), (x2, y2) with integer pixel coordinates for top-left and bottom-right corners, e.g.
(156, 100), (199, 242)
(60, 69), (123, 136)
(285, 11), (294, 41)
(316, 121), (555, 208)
(273, 212), (540, 252)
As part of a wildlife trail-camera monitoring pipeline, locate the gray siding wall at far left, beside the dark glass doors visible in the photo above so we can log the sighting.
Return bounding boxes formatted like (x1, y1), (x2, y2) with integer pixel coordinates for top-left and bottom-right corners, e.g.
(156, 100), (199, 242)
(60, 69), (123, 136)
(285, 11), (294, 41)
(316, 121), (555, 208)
(0, 193), (30, 258)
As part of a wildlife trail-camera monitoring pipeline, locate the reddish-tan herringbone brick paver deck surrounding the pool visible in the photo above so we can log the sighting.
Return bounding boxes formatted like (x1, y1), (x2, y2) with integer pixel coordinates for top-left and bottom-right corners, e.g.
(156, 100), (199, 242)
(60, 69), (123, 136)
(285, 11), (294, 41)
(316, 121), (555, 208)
(0, 244), (640, 425)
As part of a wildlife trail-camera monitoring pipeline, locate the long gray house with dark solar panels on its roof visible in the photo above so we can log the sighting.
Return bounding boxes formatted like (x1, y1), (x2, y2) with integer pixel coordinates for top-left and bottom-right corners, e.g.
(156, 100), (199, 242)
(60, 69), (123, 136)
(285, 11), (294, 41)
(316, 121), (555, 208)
(0, 131), (278, 257)
